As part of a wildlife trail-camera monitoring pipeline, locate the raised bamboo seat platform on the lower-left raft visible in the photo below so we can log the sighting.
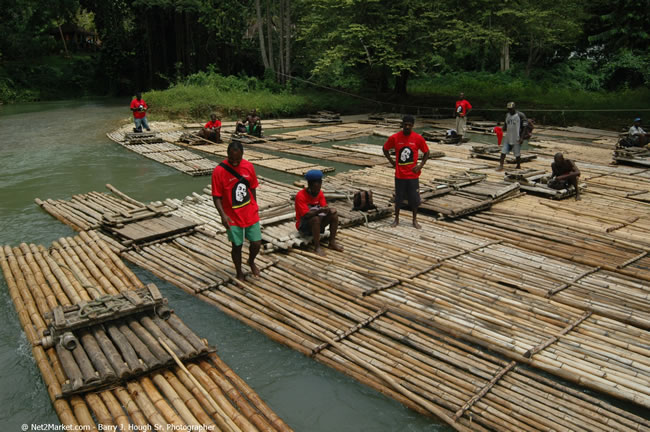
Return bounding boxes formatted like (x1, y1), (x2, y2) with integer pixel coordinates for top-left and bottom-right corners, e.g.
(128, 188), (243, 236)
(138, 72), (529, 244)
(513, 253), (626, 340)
(40, 284), (215, 398)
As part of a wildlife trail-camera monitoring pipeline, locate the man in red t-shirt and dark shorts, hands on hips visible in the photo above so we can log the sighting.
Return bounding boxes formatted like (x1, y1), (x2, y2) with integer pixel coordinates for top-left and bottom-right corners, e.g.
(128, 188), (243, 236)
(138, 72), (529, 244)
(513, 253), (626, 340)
(384, 115), (429, 229)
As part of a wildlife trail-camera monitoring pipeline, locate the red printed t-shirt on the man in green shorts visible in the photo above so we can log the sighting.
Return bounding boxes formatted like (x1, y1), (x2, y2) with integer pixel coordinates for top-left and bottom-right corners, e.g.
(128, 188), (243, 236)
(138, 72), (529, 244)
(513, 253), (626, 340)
(212, 159), (260, 228)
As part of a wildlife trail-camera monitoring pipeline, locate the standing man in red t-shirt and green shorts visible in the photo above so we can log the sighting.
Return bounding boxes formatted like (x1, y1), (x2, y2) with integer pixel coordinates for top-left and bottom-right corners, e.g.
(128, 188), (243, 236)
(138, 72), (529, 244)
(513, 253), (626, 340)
(212, 141), (262, 280)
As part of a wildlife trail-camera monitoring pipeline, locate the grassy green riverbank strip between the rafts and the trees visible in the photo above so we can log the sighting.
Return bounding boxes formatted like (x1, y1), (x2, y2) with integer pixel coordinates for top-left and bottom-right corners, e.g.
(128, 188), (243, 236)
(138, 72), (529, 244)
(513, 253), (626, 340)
(144, 72), (650, 130)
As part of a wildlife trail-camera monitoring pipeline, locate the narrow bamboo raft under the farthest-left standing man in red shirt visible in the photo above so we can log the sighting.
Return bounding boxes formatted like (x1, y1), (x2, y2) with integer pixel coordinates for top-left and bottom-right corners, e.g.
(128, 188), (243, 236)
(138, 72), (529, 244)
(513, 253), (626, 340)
(107, 123), (216, 176)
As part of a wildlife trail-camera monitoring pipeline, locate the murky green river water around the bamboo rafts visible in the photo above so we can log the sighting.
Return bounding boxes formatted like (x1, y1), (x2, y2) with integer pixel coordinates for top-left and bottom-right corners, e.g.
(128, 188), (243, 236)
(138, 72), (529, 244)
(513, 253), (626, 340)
(0, 100), (450, 432)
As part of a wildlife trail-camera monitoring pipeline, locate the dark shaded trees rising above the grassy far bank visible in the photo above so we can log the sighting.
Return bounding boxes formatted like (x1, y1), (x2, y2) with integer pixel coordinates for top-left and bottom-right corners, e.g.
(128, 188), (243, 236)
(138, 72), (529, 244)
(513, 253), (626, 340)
(0, 0), (650, 101)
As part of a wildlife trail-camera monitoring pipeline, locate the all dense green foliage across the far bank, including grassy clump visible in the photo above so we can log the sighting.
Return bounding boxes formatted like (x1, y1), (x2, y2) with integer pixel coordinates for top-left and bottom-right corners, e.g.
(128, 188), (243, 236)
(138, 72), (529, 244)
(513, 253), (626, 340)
(0, 0), (650, 125)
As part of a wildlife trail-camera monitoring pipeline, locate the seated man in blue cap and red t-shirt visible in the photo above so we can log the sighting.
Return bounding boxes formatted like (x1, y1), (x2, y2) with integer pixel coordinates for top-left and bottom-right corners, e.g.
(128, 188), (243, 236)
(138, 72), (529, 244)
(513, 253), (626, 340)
(295, 170), (343, 256)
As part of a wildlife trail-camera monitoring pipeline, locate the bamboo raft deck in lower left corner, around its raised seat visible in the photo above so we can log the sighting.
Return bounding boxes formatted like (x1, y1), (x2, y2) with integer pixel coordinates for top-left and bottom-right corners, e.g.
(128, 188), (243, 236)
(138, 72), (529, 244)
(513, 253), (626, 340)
(0, 232), (290, 431)
